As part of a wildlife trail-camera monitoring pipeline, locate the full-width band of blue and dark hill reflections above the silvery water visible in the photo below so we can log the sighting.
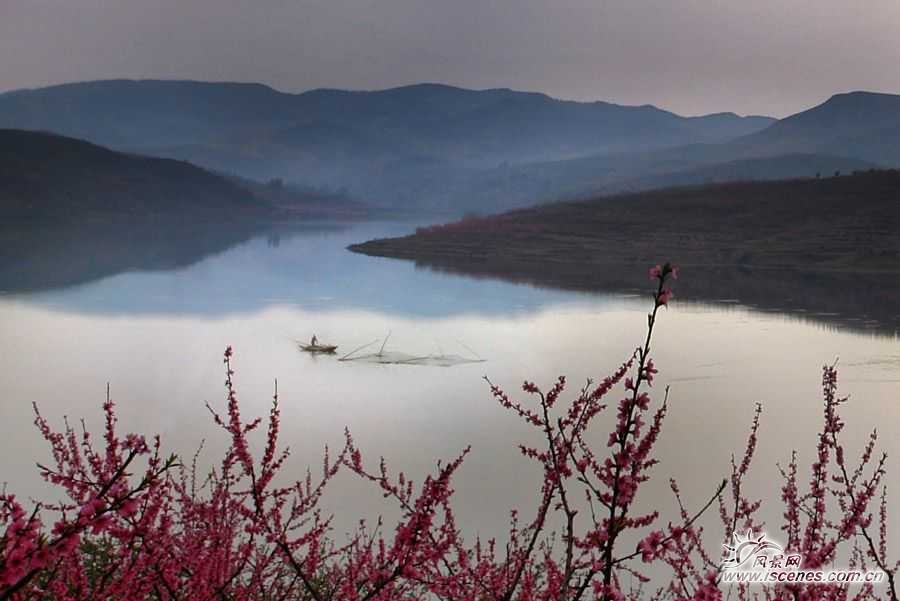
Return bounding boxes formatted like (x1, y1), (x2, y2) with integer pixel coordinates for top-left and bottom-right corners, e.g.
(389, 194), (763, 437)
(0, 222), (900, 338)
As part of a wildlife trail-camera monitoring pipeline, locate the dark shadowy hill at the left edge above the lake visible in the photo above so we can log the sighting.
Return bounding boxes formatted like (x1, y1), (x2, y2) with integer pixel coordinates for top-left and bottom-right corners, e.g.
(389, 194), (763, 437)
(0, 130), (270, 220)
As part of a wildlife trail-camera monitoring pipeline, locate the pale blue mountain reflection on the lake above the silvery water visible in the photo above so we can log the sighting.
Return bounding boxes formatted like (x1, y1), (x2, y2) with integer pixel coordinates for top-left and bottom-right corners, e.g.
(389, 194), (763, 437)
(0, 224), (592, 318)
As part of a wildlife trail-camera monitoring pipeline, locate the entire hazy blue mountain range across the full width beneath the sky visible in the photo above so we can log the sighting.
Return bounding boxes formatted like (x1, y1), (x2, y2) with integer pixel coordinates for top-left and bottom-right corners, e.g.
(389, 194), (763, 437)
(0, 80), (900, 214)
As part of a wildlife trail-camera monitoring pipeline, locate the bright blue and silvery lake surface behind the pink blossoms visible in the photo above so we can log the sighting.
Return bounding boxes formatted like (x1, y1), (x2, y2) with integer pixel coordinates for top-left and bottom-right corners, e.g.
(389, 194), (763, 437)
(0, 223), (900, 540)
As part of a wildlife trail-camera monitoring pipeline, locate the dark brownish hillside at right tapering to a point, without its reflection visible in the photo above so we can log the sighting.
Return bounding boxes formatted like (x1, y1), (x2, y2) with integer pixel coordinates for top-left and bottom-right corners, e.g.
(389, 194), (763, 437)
(352, 171), (900, 272)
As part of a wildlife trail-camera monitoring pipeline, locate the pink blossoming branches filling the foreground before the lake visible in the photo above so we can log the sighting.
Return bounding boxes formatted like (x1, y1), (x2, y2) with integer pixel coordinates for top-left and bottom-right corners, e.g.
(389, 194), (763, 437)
(0, 264), (898, 601)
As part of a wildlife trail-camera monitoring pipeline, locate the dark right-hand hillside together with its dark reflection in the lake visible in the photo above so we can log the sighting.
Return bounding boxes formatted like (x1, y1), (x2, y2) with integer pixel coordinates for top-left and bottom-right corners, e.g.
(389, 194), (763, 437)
(351, 171), (900, 336)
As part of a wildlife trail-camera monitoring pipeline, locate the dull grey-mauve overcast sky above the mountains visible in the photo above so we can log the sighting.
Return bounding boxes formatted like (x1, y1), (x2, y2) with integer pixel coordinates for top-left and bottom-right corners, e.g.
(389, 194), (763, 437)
(0, 0), (900, 116)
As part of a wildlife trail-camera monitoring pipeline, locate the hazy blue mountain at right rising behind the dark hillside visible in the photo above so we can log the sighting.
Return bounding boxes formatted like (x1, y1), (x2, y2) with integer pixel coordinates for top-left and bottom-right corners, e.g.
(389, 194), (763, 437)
(482, 92), (900, 204)
